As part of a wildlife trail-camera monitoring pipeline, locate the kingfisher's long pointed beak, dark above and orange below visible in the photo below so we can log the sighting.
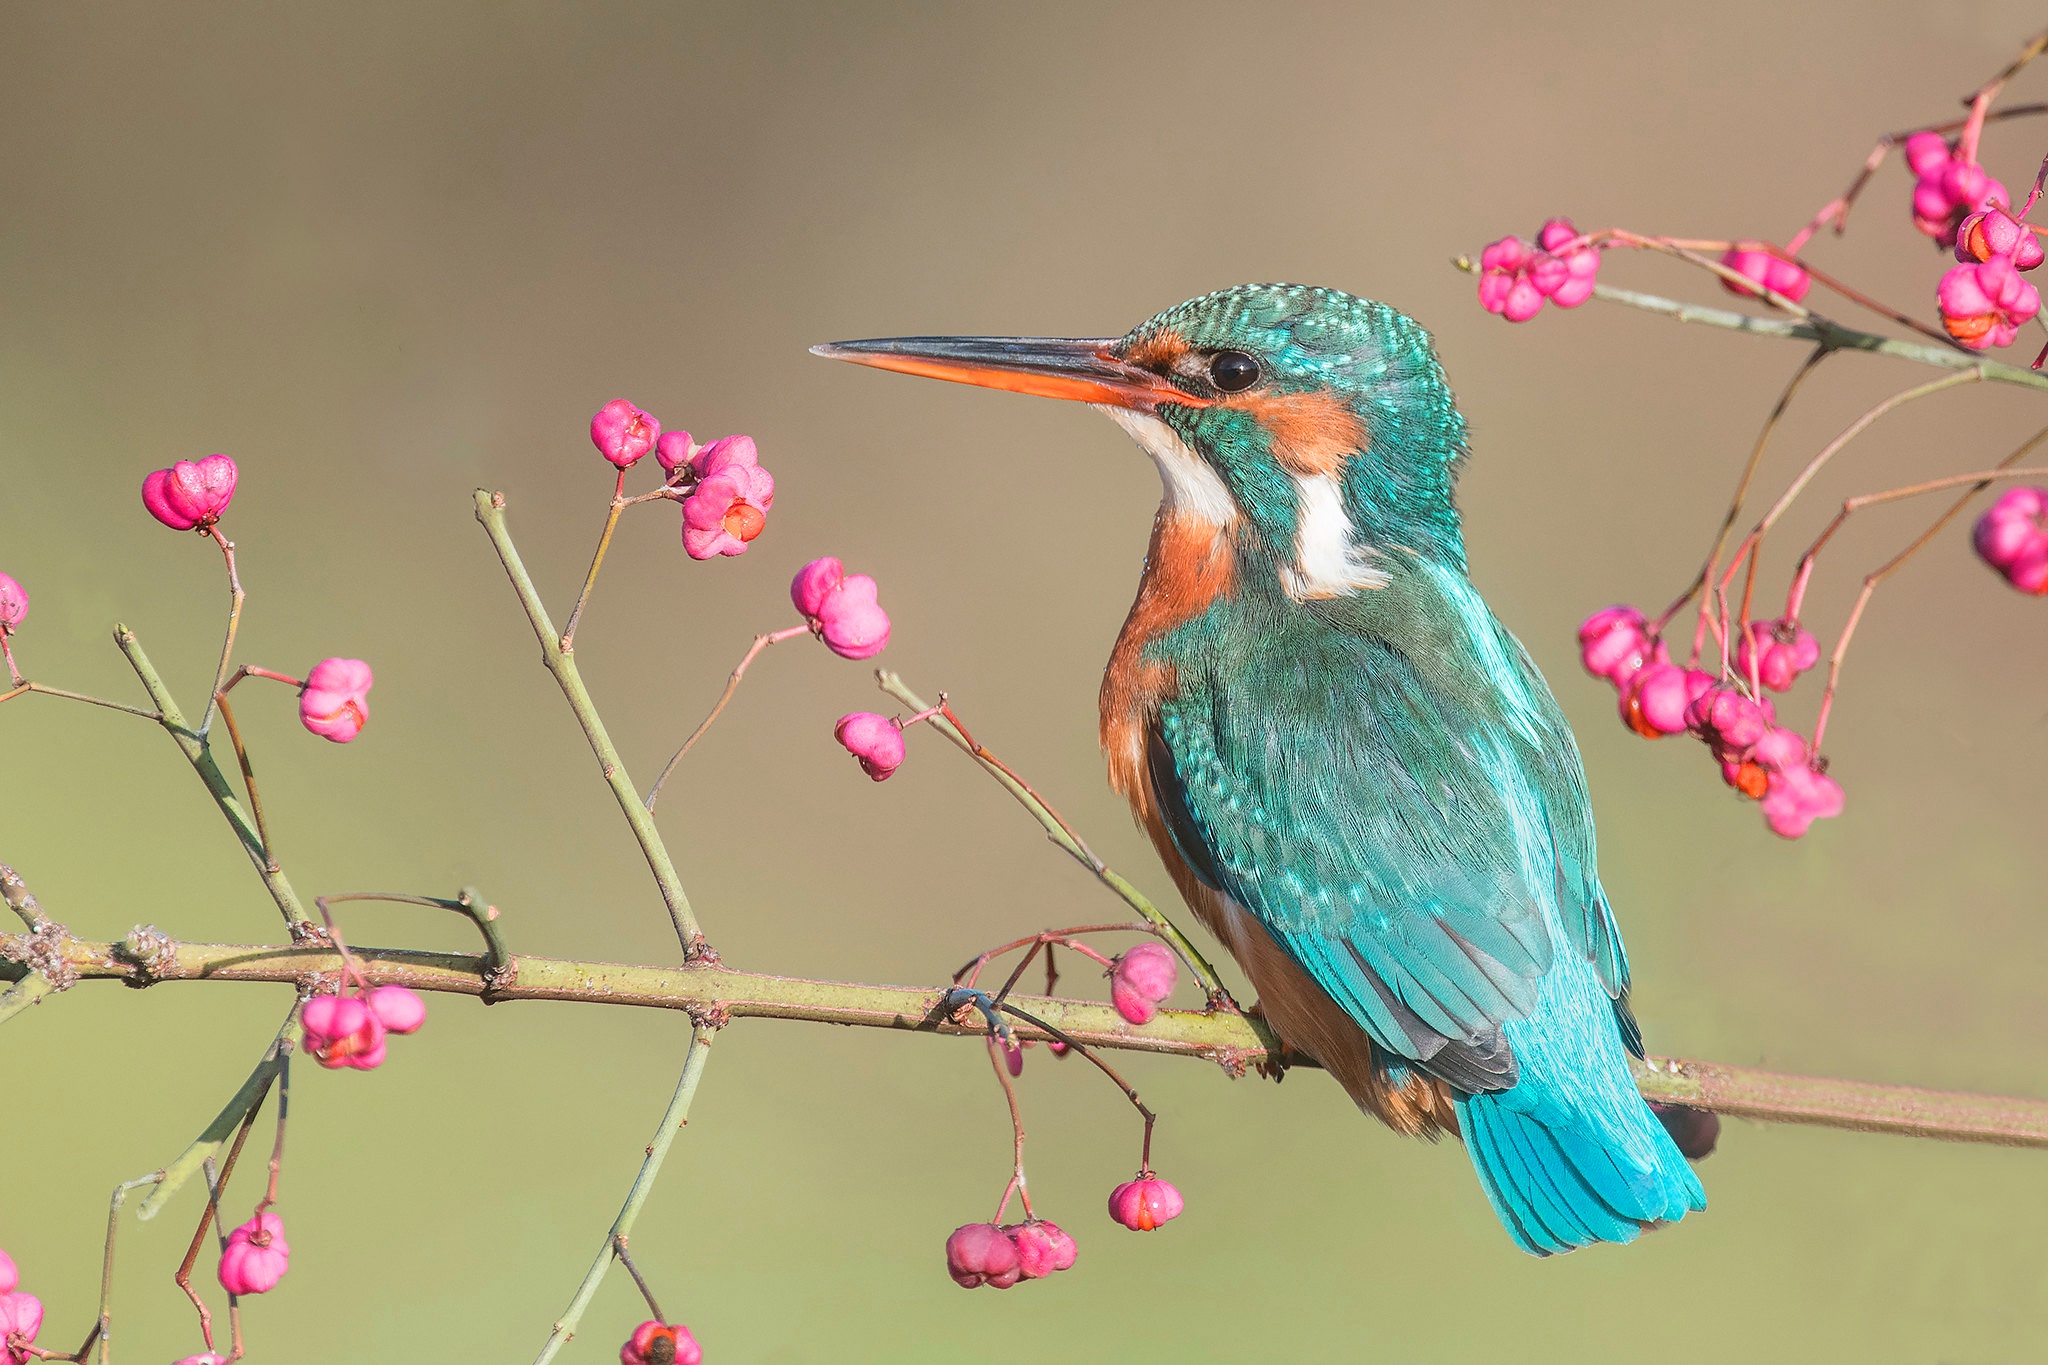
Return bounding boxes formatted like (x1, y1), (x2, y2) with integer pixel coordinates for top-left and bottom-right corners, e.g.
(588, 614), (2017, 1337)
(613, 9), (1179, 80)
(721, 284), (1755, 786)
(811, 336), (1198, 411)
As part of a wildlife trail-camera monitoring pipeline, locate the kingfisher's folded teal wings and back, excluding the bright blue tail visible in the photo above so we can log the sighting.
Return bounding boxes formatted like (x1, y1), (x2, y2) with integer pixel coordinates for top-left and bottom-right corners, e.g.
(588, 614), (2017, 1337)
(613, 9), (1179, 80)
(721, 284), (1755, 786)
(1149, 608), (1636, 1093)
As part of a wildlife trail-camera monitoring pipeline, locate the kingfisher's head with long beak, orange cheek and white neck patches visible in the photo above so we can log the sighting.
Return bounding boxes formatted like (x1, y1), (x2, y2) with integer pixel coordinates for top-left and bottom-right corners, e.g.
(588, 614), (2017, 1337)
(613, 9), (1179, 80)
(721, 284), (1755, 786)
(813, 284), (1464, 600)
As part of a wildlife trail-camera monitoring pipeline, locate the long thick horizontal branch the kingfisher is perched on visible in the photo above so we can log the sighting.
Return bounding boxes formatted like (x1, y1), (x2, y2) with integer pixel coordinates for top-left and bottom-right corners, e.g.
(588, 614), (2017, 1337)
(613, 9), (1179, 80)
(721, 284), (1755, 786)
(12, 935), (2048, 1148)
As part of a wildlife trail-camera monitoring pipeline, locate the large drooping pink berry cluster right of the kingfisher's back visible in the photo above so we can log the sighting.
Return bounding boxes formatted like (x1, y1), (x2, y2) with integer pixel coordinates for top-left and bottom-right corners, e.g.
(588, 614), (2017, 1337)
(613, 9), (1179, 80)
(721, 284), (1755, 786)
(1579, 606), (1843, 839)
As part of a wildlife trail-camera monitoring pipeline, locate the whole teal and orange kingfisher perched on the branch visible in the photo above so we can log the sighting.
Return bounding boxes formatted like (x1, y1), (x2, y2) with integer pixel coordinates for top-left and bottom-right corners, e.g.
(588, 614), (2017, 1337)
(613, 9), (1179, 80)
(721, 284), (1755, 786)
(813, 284), (1706, 1254)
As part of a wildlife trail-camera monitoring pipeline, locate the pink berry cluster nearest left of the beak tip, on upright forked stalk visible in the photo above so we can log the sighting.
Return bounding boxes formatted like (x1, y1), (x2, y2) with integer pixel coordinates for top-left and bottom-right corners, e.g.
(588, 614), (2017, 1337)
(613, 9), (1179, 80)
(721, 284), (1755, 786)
(590, 399), (774, 559)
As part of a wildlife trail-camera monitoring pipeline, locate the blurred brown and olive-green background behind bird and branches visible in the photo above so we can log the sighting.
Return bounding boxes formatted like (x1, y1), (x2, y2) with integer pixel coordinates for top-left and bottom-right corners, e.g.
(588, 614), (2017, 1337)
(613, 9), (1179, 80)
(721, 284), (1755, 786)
(0, 2), (2048, 1365)
